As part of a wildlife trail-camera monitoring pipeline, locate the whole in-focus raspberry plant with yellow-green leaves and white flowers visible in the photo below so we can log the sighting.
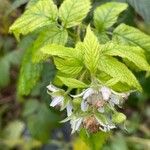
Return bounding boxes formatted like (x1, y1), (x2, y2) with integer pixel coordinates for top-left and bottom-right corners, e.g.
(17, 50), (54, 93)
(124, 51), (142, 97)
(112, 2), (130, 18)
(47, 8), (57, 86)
(10, 0), (150, 133)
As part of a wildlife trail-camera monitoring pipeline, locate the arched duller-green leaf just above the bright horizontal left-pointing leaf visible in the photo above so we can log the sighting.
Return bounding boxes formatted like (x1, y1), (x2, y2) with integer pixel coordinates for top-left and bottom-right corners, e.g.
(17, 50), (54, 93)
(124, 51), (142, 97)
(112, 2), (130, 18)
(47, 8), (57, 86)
(32, 25), (68, 62)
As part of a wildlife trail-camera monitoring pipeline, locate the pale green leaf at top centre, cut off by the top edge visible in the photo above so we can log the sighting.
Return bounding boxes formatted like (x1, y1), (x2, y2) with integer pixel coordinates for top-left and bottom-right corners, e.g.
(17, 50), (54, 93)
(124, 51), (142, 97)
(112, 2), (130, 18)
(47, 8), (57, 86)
(59, 0), (91, 28)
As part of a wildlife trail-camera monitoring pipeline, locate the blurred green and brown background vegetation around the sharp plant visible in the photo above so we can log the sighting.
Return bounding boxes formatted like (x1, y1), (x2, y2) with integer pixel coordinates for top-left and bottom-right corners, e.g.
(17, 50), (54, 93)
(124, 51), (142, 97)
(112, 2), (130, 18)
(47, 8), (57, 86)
(0, 0), (150, 150)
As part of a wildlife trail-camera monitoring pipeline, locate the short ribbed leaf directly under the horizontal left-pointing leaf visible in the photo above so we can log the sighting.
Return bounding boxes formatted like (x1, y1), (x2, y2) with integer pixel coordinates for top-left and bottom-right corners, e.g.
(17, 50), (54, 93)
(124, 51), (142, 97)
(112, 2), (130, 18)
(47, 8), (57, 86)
(54, 57), (83, 75)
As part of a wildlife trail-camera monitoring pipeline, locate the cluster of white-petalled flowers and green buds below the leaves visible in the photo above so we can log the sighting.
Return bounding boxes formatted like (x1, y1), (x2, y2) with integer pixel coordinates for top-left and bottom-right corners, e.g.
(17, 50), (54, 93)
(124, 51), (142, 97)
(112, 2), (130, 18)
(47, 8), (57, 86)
(47, 84), (129, 133)
